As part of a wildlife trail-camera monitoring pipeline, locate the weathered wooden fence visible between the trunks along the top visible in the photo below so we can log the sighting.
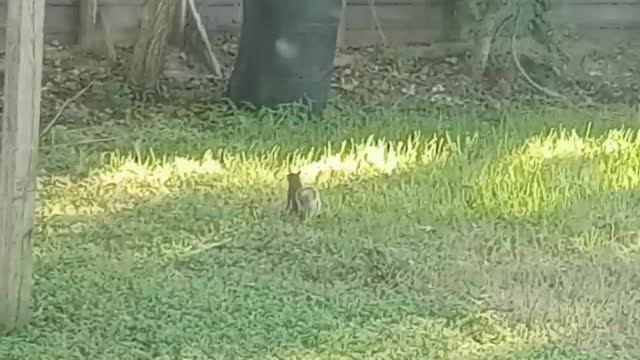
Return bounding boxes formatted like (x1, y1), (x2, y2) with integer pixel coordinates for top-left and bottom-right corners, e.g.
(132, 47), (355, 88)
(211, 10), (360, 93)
(0, 0), (640, 46)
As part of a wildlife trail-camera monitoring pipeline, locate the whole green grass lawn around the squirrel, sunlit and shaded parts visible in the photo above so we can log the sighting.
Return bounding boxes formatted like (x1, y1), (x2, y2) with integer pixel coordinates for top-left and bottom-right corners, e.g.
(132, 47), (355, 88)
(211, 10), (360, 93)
(0, 102), (640, 360)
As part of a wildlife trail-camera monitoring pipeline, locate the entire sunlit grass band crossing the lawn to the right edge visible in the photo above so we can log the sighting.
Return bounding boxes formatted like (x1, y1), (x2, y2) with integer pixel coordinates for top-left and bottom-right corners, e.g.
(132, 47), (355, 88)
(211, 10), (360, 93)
(39, 124), (640, 225)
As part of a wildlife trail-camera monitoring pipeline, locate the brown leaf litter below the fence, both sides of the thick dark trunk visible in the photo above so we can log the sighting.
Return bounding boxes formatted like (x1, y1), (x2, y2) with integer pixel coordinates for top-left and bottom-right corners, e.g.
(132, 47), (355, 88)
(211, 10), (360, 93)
(5, 36), (640, 134)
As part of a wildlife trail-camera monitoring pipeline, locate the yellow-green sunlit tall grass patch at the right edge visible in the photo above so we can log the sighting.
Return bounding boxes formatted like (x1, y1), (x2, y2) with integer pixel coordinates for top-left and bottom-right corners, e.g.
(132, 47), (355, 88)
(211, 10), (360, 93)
(471, 130), (640, 218)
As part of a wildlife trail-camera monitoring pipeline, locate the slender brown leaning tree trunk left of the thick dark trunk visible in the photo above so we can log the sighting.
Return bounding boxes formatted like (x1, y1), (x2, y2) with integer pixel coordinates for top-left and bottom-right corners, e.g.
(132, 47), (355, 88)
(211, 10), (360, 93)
(129, 0), (180, 87)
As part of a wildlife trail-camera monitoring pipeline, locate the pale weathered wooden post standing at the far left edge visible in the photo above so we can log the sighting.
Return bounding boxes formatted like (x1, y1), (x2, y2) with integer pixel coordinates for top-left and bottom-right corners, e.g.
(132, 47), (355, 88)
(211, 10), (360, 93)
(0, 0), (45, 332)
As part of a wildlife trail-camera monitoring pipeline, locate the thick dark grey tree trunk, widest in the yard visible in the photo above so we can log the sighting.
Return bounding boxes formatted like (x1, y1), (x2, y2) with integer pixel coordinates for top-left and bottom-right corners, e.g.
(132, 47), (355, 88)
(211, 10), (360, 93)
(227, 0), (342, 113)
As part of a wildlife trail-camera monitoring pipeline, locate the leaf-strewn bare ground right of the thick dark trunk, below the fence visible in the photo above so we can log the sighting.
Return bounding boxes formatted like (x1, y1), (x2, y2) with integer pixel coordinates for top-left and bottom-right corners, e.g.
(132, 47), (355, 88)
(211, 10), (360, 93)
(335, 35), (640, 109)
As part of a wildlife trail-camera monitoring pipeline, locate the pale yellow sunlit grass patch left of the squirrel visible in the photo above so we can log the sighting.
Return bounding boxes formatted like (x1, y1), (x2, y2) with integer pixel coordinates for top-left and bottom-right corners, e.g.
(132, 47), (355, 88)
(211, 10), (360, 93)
(39, 153), (223, 219)
